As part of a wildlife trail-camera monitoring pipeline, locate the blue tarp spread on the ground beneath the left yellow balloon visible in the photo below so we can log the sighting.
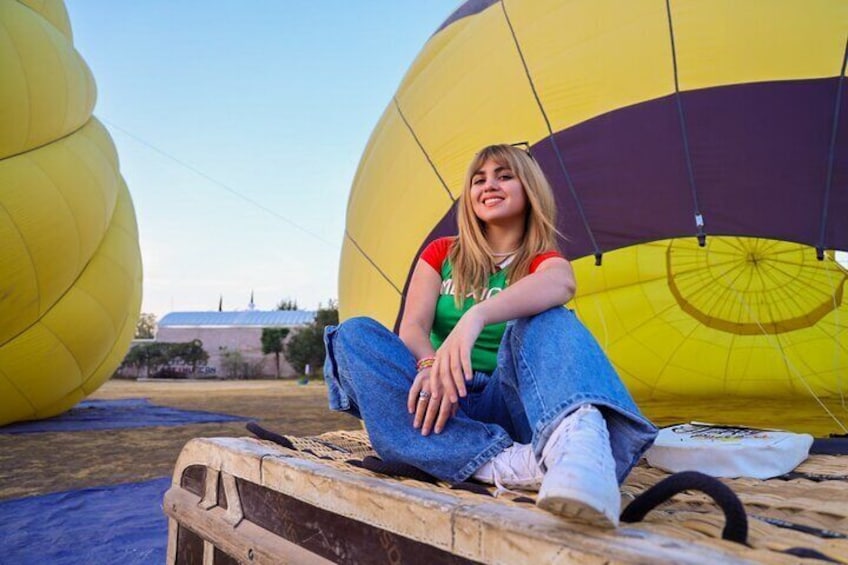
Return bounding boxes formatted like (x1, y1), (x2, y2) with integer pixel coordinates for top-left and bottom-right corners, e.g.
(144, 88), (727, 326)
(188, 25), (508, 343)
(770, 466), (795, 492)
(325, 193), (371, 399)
(0, 398), (250, 434)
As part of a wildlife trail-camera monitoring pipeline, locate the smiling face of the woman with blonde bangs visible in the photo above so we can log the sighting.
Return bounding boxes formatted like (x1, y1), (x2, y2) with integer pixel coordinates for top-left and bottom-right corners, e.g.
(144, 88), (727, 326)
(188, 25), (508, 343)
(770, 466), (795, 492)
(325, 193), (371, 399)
(469, 159), (527, 225)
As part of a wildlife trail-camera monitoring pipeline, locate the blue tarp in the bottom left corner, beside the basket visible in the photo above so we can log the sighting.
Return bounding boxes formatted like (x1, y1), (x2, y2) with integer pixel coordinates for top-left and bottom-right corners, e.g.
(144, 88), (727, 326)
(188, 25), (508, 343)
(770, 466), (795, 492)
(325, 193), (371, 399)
(0, 477), (171, 565)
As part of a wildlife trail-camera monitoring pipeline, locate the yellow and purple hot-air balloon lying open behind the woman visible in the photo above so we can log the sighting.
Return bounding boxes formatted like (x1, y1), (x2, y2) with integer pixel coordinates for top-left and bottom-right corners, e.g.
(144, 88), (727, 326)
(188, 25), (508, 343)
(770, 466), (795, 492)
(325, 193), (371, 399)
(339, 0), (848, 426)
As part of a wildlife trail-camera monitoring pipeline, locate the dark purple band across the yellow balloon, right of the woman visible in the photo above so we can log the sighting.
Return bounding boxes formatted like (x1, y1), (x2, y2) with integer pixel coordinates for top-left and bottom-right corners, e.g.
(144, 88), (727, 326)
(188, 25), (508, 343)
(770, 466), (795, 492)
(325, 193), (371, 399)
(532, 78), (848, 258)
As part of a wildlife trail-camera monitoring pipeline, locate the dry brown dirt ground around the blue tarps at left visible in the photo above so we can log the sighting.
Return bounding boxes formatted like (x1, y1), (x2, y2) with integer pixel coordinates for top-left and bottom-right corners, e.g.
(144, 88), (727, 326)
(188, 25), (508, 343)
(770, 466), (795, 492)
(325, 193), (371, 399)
(0, 380), (359, 500)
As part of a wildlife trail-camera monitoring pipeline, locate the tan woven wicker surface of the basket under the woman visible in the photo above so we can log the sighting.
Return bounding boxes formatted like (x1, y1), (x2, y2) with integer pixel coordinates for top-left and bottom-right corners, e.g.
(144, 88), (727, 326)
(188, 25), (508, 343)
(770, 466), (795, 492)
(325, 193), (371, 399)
(264, 430), (848, 563)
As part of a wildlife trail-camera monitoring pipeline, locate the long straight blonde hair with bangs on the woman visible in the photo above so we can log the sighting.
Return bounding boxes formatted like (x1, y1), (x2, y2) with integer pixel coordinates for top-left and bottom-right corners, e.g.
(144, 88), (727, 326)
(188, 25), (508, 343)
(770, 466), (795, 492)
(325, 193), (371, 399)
(449, 145), (559, 308)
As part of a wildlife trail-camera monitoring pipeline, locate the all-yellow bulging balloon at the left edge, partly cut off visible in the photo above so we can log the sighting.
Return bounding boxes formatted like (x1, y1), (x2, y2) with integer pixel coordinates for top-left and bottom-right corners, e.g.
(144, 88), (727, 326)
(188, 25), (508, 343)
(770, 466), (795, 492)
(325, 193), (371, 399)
(0, 0), (141, 425)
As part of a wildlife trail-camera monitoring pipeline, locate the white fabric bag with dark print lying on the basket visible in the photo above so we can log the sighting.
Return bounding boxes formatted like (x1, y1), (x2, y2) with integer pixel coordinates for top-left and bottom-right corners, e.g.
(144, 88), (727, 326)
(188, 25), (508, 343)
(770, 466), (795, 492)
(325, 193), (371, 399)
(645, 422), (813, 479)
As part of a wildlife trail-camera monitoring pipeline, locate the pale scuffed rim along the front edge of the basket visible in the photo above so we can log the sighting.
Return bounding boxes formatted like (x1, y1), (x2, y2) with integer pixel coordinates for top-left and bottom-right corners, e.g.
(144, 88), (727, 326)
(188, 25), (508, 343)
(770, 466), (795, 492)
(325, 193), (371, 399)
(169, 438), (793, 564)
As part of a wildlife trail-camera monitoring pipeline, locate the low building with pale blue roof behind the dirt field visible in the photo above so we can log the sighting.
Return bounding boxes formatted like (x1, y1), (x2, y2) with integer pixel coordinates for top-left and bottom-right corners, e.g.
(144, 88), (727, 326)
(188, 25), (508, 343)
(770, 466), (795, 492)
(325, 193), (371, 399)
(156, 310), (315, 378)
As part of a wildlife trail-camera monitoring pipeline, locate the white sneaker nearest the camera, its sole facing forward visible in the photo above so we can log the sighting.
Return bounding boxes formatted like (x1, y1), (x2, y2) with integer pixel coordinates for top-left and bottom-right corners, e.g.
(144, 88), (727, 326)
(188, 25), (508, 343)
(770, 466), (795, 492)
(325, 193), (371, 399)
(536, 404), (621, 528)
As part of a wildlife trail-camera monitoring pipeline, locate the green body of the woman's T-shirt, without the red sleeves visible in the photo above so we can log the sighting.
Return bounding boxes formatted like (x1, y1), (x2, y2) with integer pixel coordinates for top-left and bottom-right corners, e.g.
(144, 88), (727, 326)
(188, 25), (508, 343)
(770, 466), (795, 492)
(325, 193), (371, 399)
(430, 261), (509, 373)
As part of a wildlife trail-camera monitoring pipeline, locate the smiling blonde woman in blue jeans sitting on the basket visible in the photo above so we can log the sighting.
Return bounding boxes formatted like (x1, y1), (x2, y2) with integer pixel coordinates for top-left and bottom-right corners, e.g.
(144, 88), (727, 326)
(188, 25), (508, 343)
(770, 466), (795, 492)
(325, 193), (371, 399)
(324, 145), (656, 527)
